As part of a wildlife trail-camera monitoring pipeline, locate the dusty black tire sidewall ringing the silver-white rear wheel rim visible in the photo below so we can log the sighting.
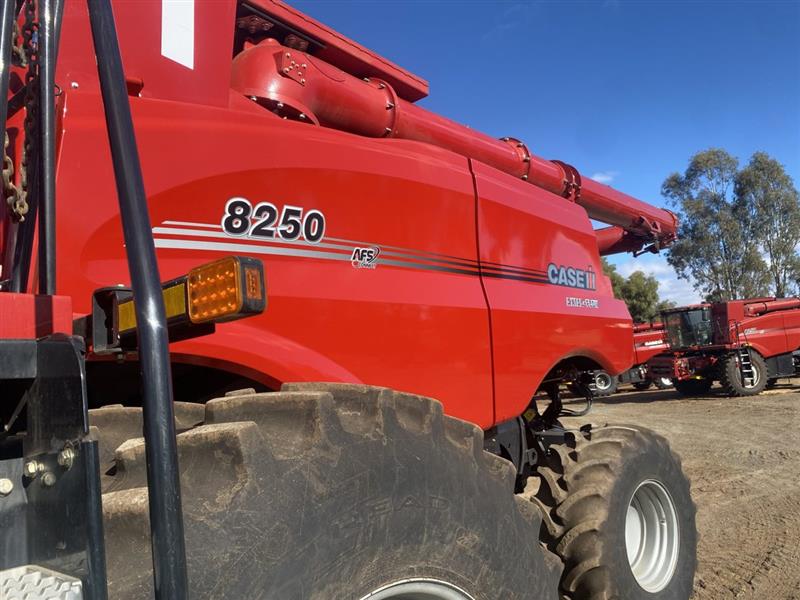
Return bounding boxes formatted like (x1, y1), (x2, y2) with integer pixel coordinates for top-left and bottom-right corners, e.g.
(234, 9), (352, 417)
(603, 441), (697, 600)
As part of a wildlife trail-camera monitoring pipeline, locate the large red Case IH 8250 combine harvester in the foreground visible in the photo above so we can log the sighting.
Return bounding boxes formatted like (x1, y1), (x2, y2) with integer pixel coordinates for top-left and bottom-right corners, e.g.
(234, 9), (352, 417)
(0, 0), (696, 600)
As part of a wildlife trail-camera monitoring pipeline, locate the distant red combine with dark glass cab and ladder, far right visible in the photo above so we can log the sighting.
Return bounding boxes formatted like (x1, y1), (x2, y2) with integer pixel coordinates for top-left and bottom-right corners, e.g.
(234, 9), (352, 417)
(652, 298), (800, 396)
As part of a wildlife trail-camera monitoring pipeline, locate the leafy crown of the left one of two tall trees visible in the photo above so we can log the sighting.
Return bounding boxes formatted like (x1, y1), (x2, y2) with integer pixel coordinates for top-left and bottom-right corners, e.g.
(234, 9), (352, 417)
(662, 148), (769, 300)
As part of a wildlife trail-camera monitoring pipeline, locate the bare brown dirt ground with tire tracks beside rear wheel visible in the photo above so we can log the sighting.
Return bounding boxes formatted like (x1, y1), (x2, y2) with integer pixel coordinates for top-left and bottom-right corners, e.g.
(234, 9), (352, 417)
(564, 379), (800, 600)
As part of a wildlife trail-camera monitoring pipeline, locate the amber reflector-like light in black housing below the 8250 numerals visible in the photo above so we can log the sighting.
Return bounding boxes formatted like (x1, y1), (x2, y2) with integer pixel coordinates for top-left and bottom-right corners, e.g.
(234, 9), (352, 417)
(186, 256), (266, 323)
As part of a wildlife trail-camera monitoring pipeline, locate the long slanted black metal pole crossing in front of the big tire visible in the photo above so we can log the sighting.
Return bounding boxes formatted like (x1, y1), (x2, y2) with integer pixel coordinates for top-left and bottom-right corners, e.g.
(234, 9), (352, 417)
(87, 0), (188, 600)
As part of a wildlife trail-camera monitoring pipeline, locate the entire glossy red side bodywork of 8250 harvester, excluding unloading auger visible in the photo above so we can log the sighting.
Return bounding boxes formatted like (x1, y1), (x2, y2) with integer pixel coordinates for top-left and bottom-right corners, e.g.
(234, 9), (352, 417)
(3, 0), (664, 428)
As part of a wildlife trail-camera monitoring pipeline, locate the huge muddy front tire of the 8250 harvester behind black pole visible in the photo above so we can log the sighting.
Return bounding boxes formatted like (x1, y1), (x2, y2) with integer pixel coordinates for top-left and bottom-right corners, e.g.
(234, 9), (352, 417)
(90, 384), (561, 600)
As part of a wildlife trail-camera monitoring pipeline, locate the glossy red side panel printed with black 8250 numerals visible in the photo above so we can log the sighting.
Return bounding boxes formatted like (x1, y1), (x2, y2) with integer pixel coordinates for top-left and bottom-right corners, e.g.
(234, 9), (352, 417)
(58, 90), (493, 427)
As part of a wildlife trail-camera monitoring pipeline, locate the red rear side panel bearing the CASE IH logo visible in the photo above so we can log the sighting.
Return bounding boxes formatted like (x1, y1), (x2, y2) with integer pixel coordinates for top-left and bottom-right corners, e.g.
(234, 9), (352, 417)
(473, 163), (633, 421)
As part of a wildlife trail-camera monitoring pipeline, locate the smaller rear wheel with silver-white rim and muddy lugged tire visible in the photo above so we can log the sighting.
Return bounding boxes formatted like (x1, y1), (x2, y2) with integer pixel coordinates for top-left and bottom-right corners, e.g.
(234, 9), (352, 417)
(523, 426), (697, 600)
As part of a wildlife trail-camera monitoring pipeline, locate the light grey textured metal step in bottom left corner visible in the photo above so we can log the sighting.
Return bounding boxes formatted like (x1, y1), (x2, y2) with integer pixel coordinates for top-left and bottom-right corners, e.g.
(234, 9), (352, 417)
(0, 565), (83, 600)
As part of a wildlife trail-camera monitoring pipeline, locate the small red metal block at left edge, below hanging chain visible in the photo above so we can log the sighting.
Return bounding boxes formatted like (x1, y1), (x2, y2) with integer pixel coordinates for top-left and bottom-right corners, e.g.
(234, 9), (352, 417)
(0, 292), (72, 340)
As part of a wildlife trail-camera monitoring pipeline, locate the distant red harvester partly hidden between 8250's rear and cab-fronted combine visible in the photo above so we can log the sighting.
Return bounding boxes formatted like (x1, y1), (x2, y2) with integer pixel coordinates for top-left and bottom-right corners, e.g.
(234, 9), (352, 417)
(590, 323), (672, 396)
